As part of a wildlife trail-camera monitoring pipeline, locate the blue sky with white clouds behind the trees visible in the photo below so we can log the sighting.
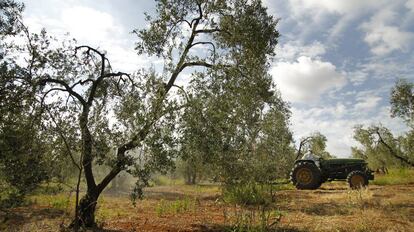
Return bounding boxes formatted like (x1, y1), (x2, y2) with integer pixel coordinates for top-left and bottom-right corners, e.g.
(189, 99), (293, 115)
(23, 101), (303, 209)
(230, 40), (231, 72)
(23, 0), (414, 157)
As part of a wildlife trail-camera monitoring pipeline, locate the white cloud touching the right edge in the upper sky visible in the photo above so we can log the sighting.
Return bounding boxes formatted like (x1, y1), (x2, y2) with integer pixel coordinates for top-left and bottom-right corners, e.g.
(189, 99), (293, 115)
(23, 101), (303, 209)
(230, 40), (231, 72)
(361, 8), (414, 56)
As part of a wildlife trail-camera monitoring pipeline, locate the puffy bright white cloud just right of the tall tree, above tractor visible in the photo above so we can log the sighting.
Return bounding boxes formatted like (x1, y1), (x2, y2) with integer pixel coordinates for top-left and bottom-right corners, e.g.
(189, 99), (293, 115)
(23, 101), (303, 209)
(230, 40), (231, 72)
(271, 56), (347, 102)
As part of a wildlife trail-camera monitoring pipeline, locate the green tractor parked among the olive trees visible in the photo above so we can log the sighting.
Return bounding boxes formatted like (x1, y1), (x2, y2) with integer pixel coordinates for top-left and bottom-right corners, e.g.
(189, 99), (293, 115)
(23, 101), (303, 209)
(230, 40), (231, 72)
(290, 154), (374, 189)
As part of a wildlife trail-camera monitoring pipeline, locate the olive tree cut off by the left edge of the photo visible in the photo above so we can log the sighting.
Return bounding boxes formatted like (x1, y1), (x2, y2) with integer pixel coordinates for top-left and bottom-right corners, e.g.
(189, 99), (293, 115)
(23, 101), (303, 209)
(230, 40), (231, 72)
(0, 0), (54, 207)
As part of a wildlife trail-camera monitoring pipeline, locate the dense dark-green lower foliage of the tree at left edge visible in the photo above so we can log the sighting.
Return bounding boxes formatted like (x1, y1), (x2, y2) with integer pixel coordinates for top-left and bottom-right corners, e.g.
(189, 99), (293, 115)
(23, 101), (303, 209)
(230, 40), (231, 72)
(0, 88), (53, 206)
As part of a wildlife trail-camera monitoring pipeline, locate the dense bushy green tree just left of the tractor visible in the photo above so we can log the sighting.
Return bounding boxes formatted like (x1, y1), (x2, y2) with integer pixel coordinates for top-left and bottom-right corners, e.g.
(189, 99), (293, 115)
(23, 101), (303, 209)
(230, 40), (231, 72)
(180, 44), (294, 186)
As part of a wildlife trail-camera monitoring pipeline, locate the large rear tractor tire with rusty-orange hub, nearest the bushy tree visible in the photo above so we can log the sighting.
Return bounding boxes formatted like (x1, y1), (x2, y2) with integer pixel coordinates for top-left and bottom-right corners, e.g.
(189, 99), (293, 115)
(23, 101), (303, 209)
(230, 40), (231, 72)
(290, 162), (322, 189)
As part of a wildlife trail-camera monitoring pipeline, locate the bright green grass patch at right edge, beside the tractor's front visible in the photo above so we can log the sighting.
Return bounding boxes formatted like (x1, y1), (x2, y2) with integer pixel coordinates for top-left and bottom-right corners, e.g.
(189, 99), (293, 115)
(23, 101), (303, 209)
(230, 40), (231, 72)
(371, 168), (414, 185)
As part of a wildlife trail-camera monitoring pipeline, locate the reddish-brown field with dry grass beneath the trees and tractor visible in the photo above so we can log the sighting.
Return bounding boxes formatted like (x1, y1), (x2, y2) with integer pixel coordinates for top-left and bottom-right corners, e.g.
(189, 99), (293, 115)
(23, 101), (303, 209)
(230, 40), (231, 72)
(0, 172), (414, 231)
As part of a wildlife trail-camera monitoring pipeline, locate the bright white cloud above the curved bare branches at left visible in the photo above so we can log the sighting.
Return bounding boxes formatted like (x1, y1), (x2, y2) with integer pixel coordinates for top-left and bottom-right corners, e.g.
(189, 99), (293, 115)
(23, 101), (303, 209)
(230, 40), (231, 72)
(25, 4), (155, 73)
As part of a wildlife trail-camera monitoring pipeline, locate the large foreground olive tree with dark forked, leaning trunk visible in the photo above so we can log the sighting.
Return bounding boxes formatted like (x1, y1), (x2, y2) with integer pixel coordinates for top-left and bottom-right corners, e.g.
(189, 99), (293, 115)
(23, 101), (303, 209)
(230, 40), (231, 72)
(0, 0), (278, 227)
